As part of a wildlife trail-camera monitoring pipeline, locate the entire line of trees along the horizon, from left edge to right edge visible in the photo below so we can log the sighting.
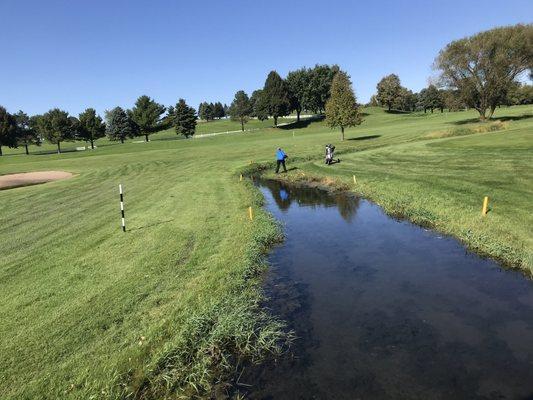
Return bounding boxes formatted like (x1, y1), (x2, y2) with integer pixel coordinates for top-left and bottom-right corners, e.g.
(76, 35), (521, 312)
(0, 24), (533, 155)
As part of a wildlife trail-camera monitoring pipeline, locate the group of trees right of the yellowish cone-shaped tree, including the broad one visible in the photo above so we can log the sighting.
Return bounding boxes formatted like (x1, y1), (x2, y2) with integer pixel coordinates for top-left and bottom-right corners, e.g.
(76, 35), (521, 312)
(370, 24), (533, 120)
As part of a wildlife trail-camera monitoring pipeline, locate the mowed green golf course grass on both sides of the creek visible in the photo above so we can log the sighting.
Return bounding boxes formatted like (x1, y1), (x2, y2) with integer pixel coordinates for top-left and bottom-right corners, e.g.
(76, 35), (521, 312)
(0, 106), (533, 399)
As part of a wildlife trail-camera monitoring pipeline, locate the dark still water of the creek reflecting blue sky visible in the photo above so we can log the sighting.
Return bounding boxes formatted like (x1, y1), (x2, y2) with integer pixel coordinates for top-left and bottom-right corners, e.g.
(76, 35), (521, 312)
(240, 182), (533, 399)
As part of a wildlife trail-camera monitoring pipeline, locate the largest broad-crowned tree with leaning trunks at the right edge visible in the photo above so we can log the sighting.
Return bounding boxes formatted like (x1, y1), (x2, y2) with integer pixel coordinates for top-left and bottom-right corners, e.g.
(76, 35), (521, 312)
(434, 24), (533, 121)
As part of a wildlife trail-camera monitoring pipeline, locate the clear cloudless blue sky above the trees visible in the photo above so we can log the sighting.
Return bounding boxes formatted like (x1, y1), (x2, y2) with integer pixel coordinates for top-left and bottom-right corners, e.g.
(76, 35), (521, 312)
(0, 0), (533, 114)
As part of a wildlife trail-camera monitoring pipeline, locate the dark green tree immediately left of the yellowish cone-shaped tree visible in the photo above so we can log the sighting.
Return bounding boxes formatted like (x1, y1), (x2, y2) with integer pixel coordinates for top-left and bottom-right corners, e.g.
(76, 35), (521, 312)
(302, 64), (339, 113)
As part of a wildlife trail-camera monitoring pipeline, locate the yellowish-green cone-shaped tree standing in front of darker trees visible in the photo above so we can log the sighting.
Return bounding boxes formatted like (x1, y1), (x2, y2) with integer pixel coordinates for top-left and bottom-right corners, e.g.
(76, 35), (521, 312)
(326, 71), (362, 140)
